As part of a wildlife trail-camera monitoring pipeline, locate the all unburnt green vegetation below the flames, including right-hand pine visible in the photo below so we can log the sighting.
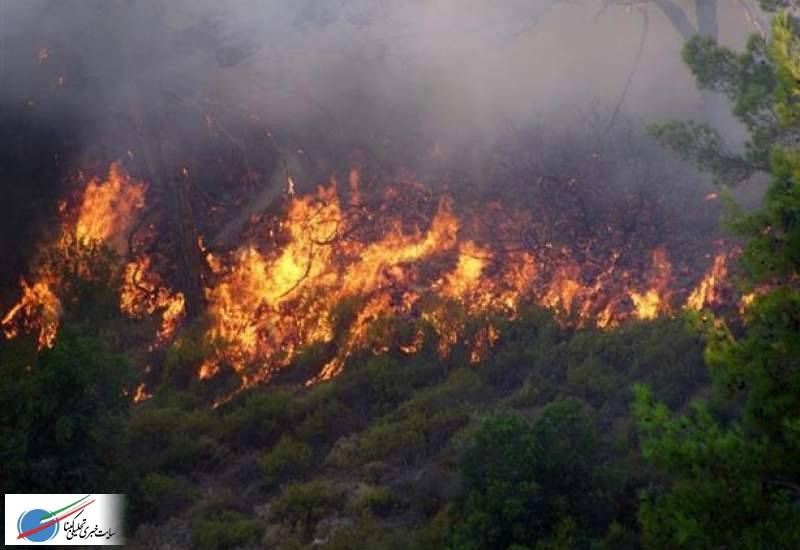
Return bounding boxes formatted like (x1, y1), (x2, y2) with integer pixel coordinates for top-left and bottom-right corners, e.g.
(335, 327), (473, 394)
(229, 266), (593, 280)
(0, 4), (800, 550)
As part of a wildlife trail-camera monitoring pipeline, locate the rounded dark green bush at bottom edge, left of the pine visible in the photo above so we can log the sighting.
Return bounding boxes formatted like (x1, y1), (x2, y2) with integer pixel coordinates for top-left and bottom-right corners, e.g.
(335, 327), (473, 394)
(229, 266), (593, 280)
(451, 399), (611, 548)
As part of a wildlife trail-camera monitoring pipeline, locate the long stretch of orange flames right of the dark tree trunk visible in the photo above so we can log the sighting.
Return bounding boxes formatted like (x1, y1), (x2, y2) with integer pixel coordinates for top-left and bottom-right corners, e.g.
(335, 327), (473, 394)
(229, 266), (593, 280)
(198, 179), (736, 387)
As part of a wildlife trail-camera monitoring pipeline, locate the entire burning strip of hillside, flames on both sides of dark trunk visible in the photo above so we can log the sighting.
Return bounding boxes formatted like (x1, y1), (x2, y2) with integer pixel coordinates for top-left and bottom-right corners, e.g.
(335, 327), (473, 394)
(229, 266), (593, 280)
(3, 151), (733, 402)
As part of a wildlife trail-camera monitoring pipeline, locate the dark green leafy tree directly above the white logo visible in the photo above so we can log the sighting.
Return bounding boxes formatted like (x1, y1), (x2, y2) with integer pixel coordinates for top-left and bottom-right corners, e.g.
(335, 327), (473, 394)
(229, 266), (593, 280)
(0, 327), (134, 492)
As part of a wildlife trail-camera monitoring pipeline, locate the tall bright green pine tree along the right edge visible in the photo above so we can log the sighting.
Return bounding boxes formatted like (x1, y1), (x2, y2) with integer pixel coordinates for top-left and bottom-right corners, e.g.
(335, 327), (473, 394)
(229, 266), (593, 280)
(634, 6), (800, 548)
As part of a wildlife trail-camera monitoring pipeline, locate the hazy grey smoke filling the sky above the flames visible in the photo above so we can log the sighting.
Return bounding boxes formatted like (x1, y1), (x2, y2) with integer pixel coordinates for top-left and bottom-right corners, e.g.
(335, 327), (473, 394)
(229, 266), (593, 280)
(0, 0), (764, 298)
